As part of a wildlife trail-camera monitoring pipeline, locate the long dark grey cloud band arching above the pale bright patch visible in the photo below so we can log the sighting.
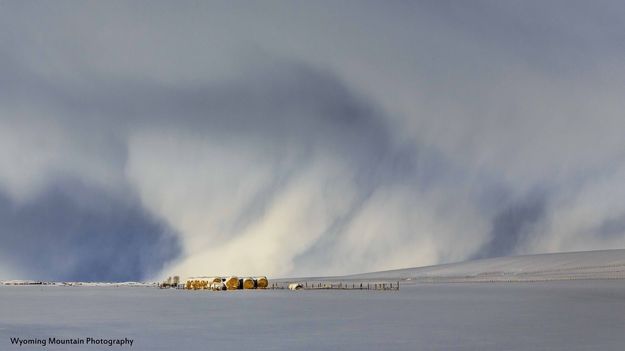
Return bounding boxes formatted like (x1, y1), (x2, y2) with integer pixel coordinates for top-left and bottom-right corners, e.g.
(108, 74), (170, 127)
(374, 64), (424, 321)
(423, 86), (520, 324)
(0, 51), (390, 160)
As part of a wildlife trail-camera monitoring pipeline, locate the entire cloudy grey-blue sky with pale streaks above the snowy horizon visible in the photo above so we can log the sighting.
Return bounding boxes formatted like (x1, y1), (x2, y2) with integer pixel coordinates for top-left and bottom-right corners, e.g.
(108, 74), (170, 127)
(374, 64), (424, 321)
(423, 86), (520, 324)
(0, 0), (625, 281)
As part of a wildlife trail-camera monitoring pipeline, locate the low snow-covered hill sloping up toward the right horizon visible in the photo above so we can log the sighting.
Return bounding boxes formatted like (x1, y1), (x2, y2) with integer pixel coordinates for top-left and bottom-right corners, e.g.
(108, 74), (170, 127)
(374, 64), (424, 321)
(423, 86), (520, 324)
(341, 250), (625, 282)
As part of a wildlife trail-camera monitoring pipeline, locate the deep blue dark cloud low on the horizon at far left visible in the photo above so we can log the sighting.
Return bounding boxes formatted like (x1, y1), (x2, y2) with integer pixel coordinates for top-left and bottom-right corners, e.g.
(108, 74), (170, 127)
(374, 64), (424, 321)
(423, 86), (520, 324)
(0, 181), (181, 281)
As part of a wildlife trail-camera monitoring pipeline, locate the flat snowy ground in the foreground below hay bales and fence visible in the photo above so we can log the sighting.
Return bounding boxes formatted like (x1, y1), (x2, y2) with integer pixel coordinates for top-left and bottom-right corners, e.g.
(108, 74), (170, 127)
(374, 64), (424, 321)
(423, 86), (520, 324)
(0, 280), (625, 350)
